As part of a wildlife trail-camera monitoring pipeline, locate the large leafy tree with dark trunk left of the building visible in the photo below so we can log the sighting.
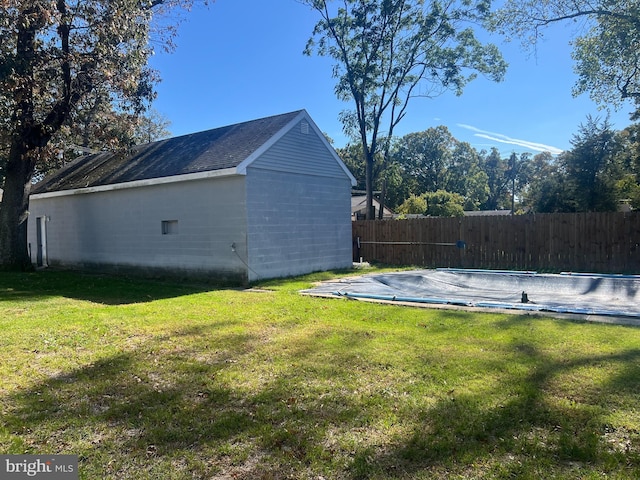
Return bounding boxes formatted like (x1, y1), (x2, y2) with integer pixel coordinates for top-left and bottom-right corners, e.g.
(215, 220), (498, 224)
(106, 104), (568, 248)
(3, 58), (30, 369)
(0, 0), (200, 269)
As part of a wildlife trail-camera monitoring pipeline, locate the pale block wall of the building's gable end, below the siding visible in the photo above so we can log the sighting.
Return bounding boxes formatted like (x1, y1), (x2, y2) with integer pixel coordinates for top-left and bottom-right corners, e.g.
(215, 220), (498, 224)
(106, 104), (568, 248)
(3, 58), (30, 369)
(247, 168), (352, 280)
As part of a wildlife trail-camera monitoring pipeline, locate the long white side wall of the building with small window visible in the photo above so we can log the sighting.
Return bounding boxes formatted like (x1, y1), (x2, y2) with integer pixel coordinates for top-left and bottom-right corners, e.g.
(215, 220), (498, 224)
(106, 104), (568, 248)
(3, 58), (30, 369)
(28, 176), (247, 280)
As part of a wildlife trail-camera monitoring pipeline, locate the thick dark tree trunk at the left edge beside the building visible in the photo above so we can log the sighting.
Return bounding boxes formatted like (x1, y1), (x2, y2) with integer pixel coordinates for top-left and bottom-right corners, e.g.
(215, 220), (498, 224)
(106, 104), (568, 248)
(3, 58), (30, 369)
(0, 139), (35, 270)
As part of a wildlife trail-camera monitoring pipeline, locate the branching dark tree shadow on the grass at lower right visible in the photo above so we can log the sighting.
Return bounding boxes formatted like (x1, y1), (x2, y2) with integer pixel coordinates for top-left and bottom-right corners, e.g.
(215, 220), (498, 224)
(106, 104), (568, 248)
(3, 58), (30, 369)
(354, 343), (640, 479)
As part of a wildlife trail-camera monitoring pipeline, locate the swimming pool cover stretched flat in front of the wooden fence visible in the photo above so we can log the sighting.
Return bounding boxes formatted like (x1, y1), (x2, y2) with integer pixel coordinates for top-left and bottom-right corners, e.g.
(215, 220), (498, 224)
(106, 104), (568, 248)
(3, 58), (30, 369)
(302, 269), (640, 319)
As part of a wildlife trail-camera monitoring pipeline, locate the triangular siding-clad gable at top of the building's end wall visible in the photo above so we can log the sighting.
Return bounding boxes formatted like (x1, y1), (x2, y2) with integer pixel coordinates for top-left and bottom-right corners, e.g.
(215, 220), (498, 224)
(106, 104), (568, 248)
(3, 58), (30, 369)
(250, 118), (348, 178)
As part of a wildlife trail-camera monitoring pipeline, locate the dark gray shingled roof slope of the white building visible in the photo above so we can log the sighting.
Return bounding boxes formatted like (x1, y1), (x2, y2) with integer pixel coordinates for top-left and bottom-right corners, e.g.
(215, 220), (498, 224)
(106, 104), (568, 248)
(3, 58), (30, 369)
(31, 110), (302, 194)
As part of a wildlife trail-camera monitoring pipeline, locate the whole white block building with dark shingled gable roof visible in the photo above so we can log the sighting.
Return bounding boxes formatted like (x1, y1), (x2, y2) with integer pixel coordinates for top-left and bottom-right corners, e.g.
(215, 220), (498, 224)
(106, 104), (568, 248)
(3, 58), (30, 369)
(28, 110), (355, 283)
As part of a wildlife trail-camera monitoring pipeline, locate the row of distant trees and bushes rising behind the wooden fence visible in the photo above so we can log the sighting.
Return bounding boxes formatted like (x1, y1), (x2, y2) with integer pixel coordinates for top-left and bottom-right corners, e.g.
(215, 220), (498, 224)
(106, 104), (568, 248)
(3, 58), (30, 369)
(338, 116), (640, 216)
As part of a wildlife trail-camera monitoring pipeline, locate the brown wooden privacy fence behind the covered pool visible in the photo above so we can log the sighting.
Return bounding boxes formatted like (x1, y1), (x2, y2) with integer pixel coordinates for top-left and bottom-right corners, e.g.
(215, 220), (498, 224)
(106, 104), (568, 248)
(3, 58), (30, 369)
(353, 212), (640, 273)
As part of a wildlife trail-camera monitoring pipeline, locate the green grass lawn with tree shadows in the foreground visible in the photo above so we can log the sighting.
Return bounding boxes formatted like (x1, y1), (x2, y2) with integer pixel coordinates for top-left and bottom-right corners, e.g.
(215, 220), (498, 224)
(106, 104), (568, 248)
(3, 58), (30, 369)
(0, 271), (640, 480)
